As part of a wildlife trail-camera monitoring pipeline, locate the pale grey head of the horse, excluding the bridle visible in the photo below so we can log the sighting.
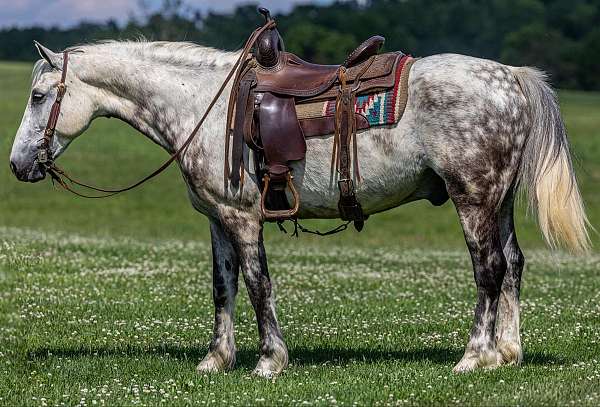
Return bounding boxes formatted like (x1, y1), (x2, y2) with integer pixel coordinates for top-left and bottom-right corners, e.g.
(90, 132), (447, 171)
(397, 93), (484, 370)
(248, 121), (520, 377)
(10, 43), (97, 182)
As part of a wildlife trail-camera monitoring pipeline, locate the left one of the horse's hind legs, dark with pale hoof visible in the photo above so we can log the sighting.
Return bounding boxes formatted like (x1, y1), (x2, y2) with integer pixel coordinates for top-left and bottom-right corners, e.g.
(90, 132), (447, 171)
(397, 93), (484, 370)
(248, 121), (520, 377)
(453, 197), (506, 372)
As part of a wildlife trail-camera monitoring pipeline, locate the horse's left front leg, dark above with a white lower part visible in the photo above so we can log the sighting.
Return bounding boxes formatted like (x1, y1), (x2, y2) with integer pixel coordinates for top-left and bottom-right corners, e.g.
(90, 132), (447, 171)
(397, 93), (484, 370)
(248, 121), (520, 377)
(198, 222), (239, 372)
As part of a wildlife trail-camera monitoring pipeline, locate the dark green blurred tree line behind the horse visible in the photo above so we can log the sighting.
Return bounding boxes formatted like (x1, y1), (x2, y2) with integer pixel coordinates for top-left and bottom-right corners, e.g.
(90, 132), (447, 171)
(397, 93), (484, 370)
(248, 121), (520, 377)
(0, 0), (600, 90)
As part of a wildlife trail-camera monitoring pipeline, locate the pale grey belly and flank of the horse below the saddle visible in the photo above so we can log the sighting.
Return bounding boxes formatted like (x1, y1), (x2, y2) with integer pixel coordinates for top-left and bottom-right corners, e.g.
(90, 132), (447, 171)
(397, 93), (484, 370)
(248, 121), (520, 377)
(288, 126), (426, 218)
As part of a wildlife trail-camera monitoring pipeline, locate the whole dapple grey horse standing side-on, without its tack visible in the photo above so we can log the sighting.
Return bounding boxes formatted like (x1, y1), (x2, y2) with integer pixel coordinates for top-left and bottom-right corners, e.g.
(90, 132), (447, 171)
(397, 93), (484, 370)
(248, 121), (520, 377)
(10, 42), (589, 376)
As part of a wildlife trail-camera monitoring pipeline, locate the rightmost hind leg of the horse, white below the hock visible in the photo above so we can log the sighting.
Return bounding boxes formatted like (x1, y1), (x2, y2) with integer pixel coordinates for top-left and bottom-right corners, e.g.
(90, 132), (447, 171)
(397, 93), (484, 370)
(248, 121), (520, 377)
(496, 191), (525, 364)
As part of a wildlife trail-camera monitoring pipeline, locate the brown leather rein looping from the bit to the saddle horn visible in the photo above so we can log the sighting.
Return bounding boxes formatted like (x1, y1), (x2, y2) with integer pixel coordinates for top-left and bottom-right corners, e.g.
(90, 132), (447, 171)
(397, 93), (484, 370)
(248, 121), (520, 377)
(47, 20), (275, 199)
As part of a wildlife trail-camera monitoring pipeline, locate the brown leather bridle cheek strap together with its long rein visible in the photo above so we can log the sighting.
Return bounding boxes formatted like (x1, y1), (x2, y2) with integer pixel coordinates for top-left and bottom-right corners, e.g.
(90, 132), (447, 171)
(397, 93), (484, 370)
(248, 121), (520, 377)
(37, 21), (275, 198)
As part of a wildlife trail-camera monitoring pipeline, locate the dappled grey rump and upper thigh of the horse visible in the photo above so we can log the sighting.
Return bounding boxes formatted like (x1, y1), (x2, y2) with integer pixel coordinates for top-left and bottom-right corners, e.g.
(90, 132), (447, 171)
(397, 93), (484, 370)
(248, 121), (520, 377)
(409, 54), (530, 200)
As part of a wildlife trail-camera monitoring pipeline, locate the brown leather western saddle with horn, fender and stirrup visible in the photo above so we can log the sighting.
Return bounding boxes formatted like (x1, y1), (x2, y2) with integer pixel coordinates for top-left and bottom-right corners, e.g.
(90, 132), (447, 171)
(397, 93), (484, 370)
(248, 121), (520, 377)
(225, 8), (404, 231)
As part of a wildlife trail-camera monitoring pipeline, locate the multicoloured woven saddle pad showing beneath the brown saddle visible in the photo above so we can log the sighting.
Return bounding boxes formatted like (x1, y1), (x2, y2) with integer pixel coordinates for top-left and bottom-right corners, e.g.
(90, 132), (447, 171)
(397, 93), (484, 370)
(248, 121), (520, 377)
(296, 55), (415, 126)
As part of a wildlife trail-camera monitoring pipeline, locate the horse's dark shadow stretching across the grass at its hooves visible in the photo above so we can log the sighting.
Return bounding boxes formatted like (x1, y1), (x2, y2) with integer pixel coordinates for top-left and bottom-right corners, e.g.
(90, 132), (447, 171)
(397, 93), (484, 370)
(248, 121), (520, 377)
(26, 345), (570, 369)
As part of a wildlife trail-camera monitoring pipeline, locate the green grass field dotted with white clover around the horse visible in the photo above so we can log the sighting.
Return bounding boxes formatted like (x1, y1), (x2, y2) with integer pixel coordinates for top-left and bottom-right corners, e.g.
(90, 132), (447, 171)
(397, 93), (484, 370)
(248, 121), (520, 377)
(0, 59), (600, 406)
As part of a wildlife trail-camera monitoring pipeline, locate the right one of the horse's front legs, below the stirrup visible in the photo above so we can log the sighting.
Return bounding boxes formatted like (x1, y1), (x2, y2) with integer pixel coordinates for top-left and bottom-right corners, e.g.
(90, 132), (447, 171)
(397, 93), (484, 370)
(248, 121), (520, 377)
(227, 215), (288, 377)
